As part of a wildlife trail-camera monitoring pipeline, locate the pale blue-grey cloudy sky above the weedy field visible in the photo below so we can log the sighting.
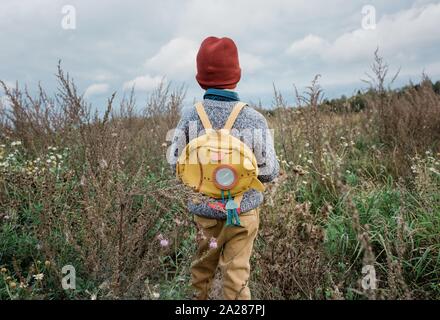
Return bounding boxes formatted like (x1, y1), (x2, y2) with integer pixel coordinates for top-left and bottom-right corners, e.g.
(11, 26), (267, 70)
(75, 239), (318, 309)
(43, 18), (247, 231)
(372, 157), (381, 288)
(0, 0), (440, 107)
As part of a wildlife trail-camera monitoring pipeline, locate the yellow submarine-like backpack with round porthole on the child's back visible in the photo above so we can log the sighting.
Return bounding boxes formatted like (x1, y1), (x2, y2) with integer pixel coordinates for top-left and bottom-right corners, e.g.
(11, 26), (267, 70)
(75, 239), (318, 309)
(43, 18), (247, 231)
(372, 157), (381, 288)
(176, 102), (264, 226)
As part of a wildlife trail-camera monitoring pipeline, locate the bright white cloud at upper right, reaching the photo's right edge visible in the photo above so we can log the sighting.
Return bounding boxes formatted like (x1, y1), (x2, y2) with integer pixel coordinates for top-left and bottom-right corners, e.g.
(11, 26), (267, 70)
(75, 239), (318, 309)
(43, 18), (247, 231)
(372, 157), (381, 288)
(287, 4), (440, 62)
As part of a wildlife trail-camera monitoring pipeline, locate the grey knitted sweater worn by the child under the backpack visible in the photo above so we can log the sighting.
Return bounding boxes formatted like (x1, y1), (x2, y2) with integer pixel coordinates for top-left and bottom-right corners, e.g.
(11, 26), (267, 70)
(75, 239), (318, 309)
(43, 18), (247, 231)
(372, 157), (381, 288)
(168, 99), (279, 219)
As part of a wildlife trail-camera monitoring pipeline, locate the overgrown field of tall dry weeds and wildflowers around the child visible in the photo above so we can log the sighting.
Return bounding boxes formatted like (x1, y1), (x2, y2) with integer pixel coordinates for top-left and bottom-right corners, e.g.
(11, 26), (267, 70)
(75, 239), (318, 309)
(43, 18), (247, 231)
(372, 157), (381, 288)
(0, 57), (440, 299)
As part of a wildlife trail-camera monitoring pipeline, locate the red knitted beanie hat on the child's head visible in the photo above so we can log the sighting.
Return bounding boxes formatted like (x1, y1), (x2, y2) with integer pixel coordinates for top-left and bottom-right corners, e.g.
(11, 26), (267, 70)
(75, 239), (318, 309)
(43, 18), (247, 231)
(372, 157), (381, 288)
(196, 37), (241, 90)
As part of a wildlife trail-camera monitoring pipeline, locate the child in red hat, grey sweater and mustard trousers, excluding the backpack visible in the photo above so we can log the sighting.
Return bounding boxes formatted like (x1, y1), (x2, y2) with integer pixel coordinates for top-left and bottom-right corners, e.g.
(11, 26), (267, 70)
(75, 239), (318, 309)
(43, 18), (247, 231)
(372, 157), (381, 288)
(170, 37), (279, 300)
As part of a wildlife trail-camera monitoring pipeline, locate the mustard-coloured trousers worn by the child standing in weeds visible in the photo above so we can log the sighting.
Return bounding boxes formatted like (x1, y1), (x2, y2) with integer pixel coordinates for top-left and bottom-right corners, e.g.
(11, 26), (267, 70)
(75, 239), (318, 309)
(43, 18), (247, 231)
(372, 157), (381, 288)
(191, 208), (259, 300)
